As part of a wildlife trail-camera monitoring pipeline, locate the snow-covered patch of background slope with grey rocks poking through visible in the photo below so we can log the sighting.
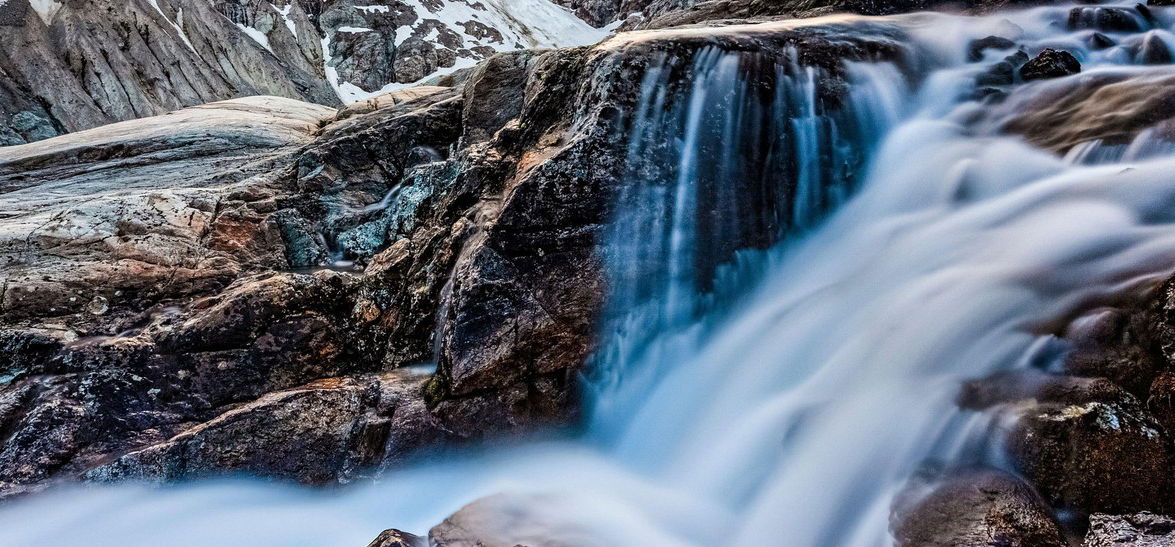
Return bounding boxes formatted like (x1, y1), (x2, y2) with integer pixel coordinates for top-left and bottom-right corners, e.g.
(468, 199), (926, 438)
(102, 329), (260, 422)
(320, 0), (609, 102)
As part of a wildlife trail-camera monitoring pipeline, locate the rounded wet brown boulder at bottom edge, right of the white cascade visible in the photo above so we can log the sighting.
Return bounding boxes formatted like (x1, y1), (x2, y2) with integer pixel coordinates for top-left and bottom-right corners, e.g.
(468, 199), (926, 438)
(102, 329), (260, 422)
(891, 470), (1068, 547)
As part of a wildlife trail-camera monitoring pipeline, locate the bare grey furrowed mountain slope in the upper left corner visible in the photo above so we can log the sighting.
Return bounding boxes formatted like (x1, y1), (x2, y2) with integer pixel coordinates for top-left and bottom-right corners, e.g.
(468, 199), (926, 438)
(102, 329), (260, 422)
(0, 0), (337, 144)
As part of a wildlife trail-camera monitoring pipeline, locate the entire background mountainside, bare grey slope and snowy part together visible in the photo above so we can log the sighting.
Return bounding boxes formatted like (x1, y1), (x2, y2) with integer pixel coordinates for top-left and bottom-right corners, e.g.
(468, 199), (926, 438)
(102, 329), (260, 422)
(0, 0), (607, 146)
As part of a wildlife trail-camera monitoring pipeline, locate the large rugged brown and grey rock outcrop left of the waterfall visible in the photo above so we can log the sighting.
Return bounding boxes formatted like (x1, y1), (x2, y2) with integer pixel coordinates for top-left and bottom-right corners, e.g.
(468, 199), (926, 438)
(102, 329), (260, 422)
(0, 15), (900, 495)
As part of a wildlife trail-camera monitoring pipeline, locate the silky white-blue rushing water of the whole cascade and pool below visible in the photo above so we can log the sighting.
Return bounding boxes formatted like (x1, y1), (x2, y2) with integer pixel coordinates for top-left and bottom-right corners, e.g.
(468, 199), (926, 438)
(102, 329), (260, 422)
(0, 8), (1175, 547)
